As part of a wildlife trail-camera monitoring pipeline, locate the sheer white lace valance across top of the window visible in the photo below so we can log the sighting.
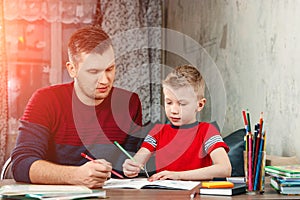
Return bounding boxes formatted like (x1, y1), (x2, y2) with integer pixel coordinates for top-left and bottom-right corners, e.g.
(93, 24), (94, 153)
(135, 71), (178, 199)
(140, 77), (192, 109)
(4, 0), (97, 24)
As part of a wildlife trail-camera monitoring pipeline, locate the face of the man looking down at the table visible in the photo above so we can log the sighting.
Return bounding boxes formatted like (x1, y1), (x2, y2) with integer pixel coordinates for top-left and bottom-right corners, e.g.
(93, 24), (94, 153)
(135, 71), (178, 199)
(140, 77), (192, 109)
(71, 47), (116, 105)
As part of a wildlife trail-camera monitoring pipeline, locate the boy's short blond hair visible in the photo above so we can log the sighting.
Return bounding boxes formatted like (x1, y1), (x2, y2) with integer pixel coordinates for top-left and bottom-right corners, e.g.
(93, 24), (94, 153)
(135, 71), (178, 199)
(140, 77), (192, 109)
(163, 65), (205, 99)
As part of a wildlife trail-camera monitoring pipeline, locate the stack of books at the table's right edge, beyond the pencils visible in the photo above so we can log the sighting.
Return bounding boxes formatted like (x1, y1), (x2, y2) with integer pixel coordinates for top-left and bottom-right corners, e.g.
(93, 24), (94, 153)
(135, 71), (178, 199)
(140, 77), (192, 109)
(265, 165), (300, 195)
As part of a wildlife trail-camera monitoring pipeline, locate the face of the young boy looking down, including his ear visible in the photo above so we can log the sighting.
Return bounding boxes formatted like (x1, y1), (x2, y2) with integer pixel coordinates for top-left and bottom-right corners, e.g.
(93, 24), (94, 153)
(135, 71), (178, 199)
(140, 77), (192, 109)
(163, 87), (206, 126)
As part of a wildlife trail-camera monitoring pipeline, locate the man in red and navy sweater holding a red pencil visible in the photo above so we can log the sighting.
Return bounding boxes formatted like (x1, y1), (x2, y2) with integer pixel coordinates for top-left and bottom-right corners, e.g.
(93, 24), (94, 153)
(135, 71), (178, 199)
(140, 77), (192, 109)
(12, 26), (142, 188)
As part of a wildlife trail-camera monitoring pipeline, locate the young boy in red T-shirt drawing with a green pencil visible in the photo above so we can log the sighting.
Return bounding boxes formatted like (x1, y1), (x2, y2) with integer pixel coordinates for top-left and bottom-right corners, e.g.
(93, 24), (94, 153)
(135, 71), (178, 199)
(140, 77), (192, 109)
(123, 65), (231, 181)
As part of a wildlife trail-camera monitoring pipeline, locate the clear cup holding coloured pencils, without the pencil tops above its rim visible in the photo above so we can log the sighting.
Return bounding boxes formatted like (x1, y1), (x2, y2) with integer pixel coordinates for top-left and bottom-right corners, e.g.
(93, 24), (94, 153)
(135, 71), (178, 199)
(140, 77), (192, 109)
(244, 151), (266, 194)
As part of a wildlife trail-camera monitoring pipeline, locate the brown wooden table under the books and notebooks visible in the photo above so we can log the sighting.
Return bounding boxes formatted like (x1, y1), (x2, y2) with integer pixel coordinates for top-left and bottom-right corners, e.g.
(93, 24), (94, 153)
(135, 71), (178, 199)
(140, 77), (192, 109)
(0, 177), (300, 200)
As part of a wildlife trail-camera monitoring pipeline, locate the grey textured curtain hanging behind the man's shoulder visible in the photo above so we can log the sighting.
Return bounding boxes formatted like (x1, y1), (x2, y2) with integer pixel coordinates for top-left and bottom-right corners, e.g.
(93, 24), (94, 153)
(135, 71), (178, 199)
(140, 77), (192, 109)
(100, 0), (161, 124)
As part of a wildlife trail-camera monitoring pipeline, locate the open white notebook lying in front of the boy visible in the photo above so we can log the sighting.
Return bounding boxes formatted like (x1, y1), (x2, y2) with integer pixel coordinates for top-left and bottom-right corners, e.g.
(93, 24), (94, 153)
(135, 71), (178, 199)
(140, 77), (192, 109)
(103, 178), (201, 190)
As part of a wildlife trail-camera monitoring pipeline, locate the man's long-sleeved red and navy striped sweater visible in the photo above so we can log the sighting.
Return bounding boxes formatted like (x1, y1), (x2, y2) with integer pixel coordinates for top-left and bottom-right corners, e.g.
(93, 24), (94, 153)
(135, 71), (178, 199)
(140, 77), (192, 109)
(12, 82), (142, 182)
